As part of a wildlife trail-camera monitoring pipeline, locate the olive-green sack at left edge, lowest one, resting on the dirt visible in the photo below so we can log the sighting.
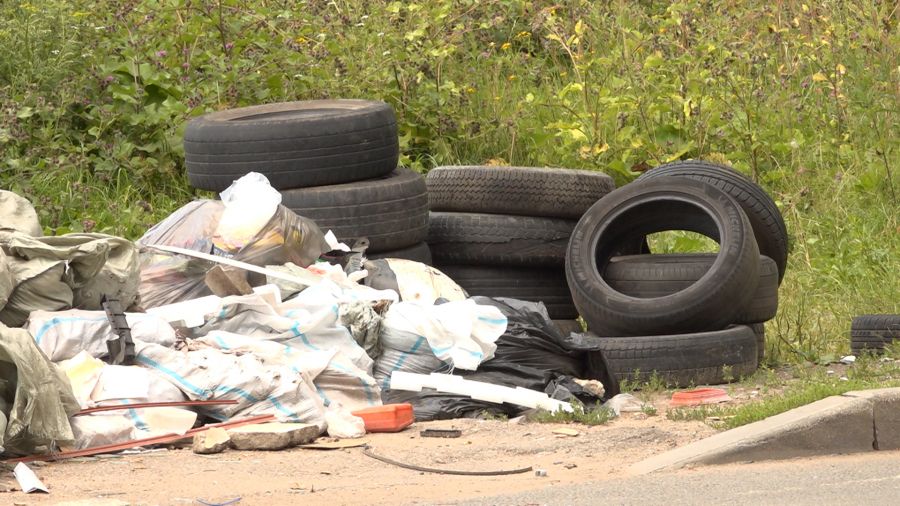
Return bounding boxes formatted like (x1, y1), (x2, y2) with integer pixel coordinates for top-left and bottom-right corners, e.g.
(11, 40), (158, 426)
(0, 324), (79, 454)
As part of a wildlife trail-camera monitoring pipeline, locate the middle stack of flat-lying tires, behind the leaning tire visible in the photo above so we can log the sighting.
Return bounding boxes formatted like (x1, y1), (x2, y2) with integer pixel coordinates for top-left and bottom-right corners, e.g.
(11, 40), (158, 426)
(426, 166), (615, 324)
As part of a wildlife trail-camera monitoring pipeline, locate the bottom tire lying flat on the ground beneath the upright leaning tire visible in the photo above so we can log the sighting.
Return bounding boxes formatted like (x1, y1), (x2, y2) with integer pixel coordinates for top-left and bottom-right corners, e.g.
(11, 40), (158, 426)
(596, 325), (757, 388)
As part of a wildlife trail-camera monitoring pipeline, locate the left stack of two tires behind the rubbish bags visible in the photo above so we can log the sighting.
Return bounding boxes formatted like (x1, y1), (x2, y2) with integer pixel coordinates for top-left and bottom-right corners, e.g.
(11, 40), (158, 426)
(184, 100), (430, 263)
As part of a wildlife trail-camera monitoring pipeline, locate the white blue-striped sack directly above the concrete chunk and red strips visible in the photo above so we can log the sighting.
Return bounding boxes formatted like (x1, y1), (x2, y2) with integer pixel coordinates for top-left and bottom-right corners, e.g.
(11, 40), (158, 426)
(135, 341), (325, 430)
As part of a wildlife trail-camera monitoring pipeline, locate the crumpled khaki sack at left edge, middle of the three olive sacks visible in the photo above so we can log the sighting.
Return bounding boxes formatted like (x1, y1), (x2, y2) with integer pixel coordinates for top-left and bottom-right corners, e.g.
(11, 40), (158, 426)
(0, 232), (139, 326)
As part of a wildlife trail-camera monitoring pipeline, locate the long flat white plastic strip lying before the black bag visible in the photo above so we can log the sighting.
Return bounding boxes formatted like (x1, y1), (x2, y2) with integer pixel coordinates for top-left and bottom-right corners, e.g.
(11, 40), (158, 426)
(390, 371), (574, 413)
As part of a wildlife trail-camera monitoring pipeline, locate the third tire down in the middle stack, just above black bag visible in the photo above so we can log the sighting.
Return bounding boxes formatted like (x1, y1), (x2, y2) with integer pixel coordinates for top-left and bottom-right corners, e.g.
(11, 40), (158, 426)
(438, 265), (578, 320)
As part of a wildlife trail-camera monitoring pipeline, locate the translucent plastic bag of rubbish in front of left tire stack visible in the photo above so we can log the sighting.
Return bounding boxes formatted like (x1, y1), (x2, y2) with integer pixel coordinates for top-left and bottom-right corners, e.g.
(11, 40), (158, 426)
(138, 186), (328, 307)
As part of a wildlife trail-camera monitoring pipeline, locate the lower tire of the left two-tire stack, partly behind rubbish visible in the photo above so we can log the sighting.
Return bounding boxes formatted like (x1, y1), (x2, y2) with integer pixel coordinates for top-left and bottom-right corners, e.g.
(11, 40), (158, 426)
(281, 168), (428, 253)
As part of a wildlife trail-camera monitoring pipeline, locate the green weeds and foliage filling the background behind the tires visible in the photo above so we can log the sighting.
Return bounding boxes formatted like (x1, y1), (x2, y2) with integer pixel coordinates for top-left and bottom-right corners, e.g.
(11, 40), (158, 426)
(0, 0), (900, 363)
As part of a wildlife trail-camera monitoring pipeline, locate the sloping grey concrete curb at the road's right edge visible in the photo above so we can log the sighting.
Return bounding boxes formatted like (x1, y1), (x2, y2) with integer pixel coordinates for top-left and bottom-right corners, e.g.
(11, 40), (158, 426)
(629, 388), (900, 474)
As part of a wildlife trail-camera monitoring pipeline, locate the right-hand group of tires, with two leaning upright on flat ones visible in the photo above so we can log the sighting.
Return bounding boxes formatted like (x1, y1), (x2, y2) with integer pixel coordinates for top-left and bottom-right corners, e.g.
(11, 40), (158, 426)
(566, 161), (787, 387)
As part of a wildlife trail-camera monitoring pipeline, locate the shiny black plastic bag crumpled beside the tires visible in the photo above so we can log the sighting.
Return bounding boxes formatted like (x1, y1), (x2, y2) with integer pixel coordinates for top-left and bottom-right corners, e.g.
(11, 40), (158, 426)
(382, 297), (619, 420)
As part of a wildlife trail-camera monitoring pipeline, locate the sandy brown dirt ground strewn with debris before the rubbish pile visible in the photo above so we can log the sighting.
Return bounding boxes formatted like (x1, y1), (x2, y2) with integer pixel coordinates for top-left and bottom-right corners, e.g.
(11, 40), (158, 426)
(0, 412), (715, 506)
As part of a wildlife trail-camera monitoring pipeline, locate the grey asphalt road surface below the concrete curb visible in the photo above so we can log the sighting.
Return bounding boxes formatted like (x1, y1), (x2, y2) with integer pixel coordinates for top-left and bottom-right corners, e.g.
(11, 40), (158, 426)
(455, 452), (900, 506)
